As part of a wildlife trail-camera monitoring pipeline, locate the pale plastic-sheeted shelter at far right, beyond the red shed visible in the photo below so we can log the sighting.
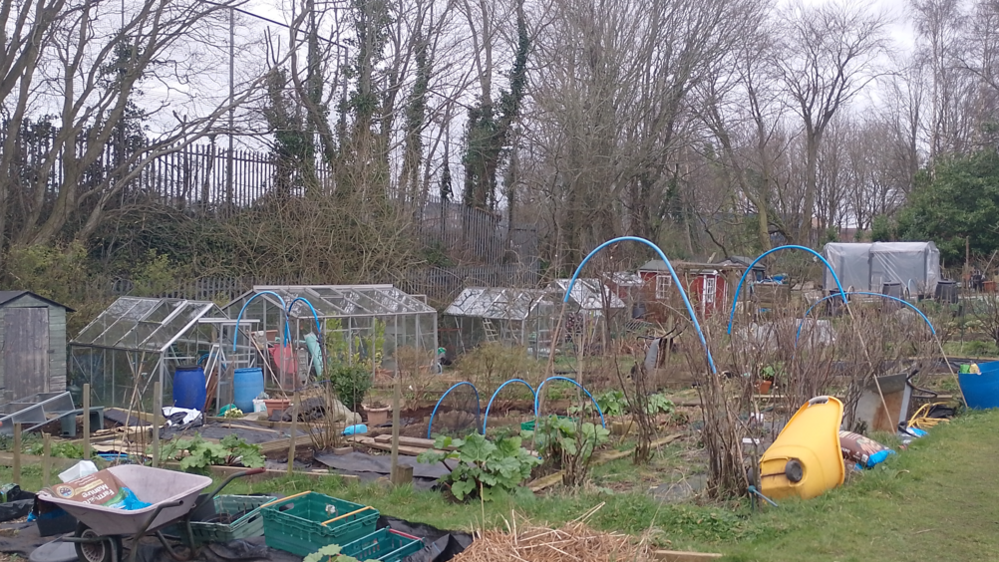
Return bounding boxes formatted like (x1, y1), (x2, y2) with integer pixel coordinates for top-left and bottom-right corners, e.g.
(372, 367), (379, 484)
(822, 242), (940, 296)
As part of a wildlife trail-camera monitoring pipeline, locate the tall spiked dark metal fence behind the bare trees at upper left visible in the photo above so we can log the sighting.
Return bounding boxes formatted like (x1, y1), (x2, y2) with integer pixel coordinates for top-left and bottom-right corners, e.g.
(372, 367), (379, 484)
(0, 127), (533, 263)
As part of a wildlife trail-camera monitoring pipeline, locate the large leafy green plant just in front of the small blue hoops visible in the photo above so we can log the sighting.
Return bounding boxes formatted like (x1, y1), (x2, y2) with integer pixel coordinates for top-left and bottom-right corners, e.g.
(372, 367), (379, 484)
(417, 433), (541, 501)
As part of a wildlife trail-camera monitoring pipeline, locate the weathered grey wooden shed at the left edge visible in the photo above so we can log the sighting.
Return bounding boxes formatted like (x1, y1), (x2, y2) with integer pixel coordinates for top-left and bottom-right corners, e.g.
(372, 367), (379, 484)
(0, 291), (73, 403)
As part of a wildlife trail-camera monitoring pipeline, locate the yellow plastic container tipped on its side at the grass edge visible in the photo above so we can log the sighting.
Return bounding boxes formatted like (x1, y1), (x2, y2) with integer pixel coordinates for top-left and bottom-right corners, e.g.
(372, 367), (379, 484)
(760, 396), (846, 500)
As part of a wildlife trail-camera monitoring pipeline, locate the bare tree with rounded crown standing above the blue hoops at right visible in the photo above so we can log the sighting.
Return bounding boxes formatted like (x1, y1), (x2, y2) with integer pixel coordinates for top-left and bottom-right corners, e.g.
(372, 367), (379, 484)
(774, 3), (888, 244)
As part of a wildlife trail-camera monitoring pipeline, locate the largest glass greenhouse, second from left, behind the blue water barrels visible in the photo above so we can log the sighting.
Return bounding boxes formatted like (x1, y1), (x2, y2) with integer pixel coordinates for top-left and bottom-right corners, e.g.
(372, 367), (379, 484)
(223, 285), (437, 378)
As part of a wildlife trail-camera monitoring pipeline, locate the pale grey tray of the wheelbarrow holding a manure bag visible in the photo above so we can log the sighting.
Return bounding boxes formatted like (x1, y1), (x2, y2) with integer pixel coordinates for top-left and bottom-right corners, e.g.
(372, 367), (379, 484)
(38, 465), (212, 536)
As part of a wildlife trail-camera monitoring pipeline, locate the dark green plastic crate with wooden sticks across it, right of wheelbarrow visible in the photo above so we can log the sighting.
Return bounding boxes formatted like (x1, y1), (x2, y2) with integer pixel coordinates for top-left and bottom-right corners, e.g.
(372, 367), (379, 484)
(262, 492), (378, 556)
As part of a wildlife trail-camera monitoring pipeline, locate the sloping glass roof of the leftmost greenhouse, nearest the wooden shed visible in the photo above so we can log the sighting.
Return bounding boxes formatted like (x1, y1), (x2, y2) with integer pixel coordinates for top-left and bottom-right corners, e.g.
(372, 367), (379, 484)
(70, 297), (224, 353)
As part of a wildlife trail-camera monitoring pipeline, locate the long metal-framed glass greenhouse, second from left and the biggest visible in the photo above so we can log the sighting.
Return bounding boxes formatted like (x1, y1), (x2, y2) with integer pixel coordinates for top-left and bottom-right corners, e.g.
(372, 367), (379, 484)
(223, 285), (437, 375)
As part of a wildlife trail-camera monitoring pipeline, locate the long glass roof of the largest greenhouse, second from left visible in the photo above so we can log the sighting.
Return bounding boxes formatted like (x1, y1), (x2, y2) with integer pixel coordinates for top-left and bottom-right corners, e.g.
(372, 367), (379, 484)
(225, 285), (437, 319)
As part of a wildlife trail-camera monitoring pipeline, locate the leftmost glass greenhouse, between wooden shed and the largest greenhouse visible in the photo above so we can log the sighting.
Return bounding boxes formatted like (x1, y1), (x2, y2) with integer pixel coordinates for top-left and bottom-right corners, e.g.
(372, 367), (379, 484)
(69, 297), (248, 411)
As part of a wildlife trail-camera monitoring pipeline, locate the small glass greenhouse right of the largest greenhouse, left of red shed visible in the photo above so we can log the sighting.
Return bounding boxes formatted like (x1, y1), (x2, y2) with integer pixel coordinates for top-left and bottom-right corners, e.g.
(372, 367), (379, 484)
(444, 287), (559, 357)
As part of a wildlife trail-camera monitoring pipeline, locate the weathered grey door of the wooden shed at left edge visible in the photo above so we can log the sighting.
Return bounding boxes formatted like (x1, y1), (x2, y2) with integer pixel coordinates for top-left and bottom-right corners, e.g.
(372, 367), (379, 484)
(3, 308), (49, 400)
